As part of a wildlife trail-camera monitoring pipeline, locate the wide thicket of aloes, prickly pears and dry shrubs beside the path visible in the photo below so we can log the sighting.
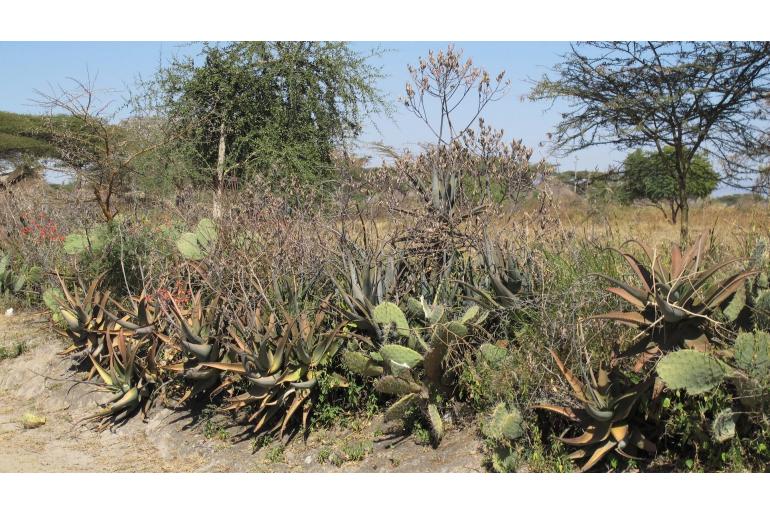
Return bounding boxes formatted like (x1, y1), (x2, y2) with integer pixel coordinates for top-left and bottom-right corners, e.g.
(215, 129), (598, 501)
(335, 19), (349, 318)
(0, 47), (770, 471)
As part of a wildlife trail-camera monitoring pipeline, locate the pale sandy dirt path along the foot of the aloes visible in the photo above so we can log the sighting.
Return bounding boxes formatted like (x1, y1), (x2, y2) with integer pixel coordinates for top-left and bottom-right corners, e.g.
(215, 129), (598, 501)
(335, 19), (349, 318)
(0, 314), (484, 472)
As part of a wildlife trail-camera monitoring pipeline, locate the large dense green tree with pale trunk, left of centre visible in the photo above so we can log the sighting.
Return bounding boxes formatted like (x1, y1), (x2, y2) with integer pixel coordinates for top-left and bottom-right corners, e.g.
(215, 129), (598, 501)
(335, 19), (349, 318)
(156, 42), (386, 217)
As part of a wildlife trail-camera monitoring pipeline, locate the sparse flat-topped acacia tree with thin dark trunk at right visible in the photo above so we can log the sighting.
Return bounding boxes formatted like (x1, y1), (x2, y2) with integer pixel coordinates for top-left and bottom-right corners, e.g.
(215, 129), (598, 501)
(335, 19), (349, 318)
(530, 41), (770, 241)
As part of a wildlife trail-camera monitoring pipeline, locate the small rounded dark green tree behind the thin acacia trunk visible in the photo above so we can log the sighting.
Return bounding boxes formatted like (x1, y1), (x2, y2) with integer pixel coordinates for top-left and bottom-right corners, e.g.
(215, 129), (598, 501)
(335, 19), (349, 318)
(622, 147), (719, 224)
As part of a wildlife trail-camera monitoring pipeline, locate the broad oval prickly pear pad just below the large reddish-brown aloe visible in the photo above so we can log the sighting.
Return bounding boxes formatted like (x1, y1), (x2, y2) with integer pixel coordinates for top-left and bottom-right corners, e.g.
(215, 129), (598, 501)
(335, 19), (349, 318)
(657, 349), (727, 395)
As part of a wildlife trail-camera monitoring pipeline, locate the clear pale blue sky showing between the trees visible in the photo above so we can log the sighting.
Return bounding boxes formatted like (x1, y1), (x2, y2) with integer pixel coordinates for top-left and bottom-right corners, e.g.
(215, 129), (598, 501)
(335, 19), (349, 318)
(0, 42), (623, 170)
